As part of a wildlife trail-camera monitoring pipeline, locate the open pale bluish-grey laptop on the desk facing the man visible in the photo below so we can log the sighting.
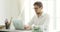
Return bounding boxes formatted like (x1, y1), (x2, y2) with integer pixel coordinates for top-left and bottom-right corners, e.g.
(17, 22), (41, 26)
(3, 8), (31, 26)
(12, 19), (24, 30)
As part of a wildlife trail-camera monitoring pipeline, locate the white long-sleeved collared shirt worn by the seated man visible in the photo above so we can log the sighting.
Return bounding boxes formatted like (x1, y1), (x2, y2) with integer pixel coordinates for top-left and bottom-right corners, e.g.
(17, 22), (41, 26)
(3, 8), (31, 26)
(29, 13), (49, 32)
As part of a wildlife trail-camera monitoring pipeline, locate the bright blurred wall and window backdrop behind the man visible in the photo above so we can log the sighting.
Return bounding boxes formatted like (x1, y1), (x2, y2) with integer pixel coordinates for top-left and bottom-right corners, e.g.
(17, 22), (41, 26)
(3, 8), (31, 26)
(0, 0), (60, 32)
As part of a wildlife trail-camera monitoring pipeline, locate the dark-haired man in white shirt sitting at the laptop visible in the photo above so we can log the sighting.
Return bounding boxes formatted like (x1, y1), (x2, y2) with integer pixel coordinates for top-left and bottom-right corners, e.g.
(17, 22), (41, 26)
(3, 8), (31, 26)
(25, 2), (49, 31)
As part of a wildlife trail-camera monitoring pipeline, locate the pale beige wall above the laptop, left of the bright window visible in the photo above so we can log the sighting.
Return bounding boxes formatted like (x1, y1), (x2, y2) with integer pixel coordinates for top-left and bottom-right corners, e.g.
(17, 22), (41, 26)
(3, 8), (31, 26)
(0, 0), (24, 19)
